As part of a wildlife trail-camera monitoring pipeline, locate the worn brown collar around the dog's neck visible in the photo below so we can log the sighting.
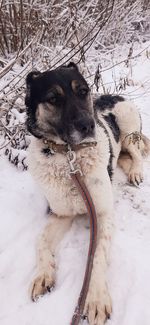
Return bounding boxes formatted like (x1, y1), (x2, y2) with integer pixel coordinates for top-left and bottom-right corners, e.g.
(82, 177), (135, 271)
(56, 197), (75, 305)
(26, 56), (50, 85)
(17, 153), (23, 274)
(43, 140), (97, 154)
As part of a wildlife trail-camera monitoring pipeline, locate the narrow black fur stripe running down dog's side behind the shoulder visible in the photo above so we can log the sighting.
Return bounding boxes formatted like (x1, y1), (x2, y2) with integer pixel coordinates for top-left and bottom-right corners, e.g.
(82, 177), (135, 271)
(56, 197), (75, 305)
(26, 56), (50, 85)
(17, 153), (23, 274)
(96, 118), (114, 181)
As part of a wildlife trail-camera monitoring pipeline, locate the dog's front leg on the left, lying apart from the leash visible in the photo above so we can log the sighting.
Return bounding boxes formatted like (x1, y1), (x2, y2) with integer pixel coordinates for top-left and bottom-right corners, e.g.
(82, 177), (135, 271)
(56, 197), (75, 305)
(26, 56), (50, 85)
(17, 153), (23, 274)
(30, 215), (72, 301)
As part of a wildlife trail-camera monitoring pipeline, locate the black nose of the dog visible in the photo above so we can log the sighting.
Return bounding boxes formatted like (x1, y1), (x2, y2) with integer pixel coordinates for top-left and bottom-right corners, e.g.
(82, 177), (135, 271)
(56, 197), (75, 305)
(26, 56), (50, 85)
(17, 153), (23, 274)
(76, 118), (95, 135)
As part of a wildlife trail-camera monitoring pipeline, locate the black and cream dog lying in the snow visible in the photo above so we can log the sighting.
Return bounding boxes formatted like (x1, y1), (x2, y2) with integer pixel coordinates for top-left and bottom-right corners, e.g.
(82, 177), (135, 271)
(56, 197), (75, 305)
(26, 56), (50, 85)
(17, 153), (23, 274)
(25, 62), (150, 325)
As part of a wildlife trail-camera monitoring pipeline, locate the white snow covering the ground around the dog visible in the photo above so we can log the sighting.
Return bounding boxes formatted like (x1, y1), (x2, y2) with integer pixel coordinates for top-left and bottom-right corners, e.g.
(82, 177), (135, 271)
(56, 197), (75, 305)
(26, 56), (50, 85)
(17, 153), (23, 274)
(0, 47), (150, 325)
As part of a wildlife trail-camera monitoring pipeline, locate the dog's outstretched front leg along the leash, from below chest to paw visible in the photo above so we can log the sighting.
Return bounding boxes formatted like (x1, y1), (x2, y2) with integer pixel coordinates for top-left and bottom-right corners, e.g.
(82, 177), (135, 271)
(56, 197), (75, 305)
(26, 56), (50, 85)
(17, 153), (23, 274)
(84, 215), (112, 325)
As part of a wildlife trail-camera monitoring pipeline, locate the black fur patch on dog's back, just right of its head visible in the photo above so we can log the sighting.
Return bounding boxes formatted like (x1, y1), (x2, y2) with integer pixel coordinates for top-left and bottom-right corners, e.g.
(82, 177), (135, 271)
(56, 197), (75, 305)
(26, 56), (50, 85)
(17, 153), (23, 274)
(94, 95), (125, 112)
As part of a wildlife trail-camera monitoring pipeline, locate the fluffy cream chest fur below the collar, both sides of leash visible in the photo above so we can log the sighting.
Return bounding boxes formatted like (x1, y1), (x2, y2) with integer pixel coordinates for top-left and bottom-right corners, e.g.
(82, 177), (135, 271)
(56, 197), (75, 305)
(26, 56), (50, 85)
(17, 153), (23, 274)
(28, 137), (108, 216)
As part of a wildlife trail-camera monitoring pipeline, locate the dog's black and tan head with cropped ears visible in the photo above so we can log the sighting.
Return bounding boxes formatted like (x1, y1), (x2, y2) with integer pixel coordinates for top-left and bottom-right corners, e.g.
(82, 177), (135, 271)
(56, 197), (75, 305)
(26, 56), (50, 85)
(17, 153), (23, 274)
(25, 63), (95, 144)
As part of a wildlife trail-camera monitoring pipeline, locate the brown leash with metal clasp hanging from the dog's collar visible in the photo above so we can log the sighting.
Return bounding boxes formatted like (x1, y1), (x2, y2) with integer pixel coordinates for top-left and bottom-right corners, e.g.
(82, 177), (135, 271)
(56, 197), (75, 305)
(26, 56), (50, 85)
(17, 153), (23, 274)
(67, 148), (97, 325)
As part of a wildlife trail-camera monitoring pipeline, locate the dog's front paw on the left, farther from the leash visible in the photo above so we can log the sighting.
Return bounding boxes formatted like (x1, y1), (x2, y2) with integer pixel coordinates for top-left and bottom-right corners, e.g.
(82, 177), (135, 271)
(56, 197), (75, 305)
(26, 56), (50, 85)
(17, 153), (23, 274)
(30, 271), (55, 301)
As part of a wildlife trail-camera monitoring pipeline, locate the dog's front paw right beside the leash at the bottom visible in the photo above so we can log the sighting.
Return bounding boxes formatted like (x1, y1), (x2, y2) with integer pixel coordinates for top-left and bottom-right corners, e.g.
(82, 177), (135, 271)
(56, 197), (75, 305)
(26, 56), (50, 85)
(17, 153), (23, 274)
(84, 284), (112, 325)
